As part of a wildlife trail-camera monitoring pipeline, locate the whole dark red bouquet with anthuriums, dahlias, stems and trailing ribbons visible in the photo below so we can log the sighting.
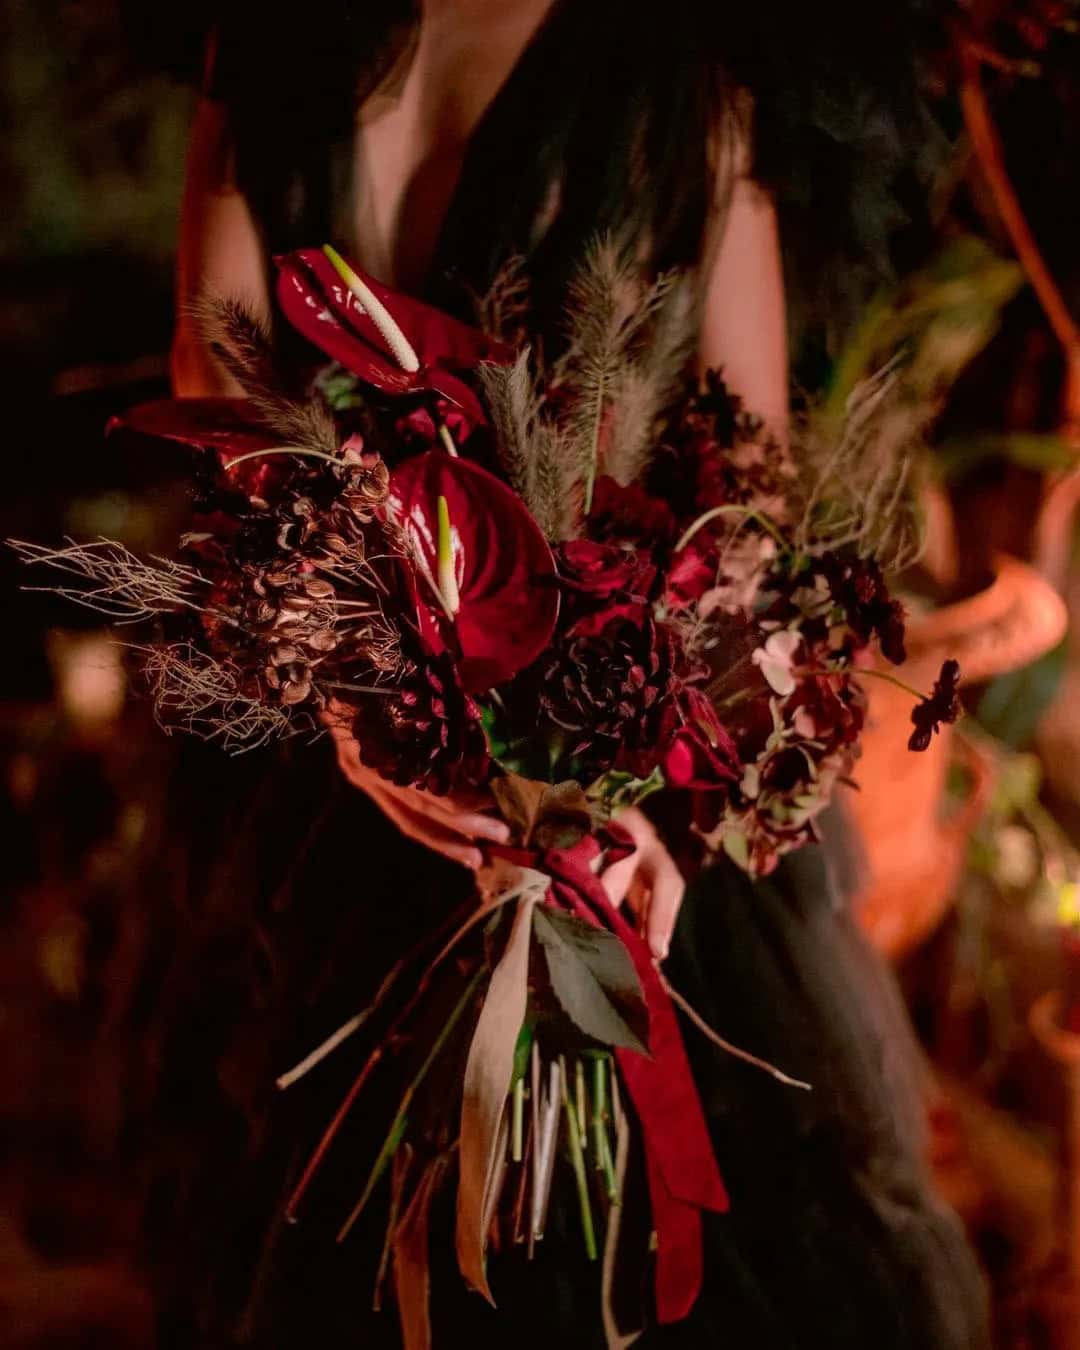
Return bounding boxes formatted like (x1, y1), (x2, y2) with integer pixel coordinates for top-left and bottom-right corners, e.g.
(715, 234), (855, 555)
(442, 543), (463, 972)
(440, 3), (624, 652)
(15, 243), (959, 1346)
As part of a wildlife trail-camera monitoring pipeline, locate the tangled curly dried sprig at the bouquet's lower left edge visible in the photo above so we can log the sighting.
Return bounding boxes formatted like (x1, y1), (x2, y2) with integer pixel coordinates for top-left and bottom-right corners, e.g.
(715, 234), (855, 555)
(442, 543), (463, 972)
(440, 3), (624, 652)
(131, 643), (303, 755)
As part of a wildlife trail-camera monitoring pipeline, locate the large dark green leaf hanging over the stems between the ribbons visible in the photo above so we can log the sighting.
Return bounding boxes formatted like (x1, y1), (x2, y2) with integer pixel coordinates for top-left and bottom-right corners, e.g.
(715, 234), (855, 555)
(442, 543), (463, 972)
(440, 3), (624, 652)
(533, 906), (649, 1054)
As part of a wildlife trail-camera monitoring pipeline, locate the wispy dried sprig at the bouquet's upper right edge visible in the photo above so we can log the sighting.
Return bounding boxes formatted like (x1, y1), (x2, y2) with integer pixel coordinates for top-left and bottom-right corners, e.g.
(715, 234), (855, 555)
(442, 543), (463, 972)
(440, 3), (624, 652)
(792, 363), (934, 572)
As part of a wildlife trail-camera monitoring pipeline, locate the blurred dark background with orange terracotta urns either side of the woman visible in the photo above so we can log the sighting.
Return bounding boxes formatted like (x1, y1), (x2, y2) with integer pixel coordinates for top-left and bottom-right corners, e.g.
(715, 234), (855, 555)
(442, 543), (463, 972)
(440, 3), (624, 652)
(0, 0), (1080, 1350)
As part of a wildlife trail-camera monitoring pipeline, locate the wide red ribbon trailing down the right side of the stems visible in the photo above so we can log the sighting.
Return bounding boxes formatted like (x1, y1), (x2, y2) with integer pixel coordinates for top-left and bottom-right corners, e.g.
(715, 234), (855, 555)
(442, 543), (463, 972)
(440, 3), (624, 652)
(498, 825), (729, 1323)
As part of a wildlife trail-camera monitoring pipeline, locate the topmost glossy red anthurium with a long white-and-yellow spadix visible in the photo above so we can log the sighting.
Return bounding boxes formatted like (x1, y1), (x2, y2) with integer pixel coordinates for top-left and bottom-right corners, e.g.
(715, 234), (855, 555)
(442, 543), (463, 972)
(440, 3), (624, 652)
(275, 246), (510, 427)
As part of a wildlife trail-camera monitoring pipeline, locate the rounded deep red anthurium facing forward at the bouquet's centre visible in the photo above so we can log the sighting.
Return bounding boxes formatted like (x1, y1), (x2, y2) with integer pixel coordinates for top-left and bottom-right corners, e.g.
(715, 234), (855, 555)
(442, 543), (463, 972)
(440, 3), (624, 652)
(389, 450), (559, 693)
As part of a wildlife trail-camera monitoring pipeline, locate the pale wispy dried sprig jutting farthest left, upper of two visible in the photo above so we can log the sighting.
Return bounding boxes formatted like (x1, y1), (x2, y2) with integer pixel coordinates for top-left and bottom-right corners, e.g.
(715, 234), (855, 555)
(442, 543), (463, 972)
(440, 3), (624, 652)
(7, 539), (209, 624)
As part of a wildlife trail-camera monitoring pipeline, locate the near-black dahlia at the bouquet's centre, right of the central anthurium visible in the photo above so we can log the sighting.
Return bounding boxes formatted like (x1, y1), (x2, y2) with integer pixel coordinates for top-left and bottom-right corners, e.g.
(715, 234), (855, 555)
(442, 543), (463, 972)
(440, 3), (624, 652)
(540, 616), (680, 778)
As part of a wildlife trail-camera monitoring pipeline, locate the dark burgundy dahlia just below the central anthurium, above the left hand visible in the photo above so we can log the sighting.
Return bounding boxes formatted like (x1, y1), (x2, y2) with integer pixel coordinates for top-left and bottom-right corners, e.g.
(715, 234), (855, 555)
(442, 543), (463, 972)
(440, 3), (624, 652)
(352, 655), (491, 794)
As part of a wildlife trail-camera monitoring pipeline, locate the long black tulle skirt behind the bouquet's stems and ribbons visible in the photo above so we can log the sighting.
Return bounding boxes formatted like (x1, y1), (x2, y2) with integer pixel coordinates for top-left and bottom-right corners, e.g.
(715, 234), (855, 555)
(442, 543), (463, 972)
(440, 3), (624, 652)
(149, 766), (987, 1350)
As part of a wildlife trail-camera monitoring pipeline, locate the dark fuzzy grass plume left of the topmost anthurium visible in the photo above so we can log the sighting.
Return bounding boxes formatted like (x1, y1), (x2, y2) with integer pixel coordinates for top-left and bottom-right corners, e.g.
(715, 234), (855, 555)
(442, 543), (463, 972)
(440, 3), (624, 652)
(192, 296), (338, 455)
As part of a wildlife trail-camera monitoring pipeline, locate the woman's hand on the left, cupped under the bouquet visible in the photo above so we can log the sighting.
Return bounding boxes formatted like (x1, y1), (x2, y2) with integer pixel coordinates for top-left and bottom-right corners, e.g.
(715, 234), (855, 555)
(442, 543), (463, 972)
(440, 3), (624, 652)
(327, 717), (510, 871)
